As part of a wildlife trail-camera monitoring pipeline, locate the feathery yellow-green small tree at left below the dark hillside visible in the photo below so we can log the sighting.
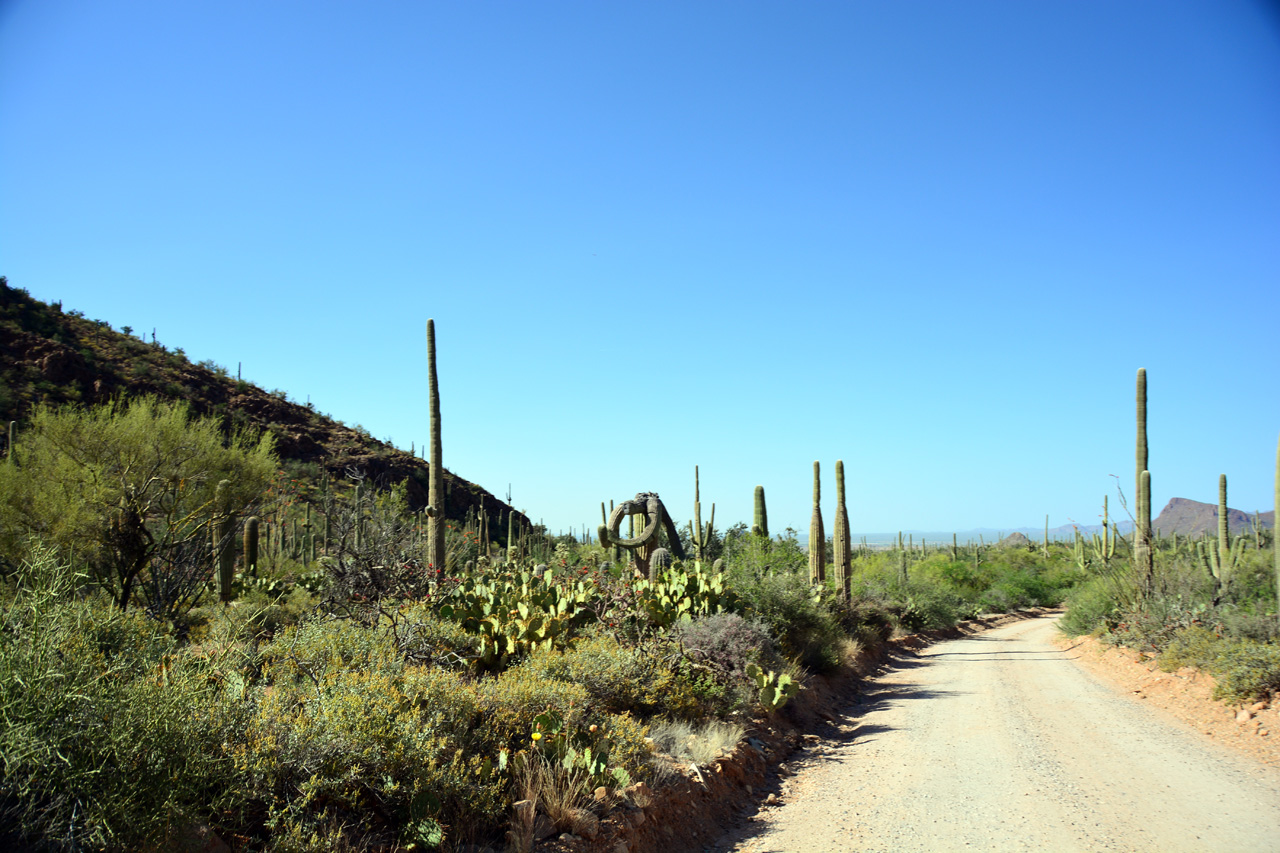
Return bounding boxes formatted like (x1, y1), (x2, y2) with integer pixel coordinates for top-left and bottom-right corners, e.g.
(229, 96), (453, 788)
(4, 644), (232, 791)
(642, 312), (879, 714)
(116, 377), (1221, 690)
(0, 397), (276, 607)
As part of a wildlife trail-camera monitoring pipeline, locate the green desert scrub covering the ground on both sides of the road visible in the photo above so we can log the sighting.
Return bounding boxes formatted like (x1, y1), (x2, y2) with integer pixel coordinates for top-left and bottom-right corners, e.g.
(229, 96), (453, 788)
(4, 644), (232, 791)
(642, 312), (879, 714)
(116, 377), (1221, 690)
(0, 281), (1259, 852)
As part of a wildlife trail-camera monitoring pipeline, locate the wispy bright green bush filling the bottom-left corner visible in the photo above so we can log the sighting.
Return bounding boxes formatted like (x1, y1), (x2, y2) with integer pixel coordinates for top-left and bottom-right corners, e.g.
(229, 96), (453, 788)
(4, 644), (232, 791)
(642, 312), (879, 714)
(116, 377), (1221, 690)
(0, 549), (239, 850)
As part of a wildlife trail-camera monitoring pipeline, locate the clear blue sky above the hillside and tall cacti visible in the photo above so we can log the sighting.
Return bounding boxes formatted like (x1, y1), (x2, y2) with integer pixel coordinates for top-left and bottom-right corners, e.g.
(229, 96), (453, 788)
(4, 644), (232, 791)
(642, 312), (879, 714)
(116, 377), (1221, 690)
(0, 0), (1280, 533)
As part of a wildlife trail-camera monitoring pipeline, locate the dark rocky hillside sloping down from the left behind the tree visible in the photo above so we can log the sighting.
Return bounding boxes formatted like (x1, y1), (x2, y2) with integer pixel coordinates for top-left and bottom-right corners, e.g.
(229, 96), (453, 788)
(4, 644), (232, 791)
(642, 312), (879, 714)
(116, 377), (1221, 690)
(0, 277), (529, 526)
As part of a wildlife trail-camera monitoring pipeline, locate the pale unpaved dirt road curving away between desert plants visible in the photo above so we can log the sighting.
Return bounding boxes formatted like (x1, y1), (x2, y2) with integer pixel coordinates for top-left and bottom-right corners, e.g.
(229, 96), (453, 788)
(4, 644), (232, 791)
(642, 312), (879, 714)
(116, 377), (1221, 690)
(723, 617), (1280, 853)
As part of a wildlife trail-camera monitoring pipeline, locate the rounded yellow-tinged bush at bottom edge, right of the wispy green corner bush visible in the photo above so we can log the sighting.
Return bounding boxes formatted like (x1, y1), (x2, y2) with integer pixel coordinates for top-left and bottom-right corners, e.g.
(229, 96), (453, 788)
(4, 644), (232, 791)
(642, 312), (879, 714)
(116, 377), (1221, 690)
(233, 656), (504, 849)
